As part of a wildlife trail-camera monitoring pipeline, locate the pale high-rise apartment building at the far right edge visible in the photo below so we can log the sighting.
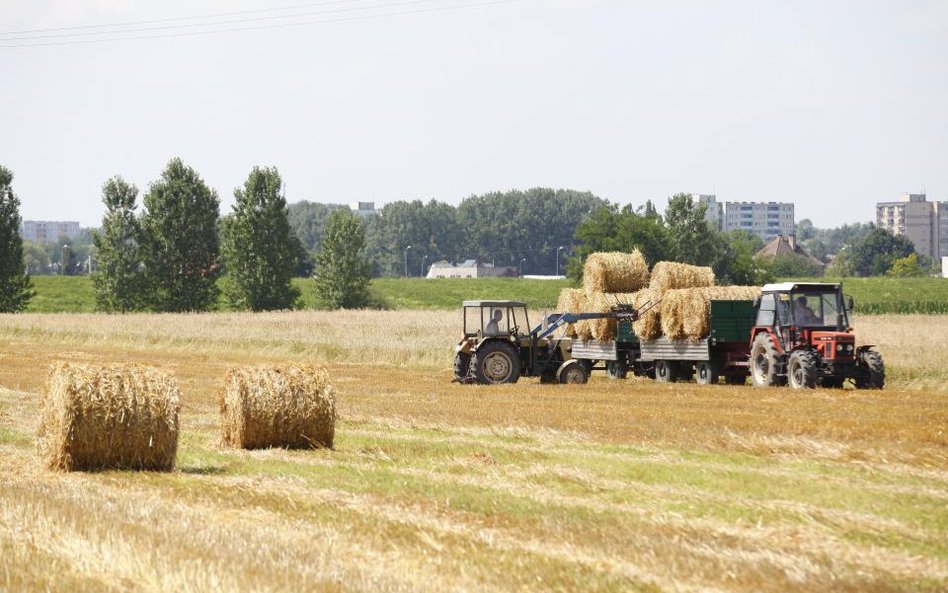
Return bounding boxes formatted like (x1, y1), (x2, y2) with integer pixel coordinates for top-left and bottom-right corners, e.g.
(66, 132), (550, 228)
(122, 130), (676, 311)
(876, 193), (948, 260)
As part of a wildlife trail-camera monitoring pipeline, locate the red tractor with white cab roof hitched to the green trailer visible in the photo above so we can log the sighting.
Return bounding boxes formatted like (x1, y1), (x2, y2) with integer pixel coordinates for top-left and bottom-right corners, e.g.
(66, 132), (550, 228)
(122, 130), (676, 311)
(749, 282), (885, 389)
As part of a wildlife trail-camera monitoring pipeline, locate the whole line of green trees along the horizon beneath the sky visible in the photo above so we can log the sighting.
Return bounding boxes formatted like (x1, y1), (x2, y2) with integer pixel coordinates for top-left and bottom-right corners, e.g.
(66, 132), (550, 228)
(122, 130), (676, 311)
(0, 159), (931, 312)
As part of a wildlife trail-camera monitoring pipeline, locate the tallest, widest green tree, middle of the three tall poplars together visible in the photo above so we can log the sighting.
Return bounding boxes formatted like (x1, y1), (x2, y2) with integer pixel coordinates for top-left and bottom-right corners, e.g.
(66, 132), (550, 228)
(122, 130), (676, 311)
(141, 158), (220, 312)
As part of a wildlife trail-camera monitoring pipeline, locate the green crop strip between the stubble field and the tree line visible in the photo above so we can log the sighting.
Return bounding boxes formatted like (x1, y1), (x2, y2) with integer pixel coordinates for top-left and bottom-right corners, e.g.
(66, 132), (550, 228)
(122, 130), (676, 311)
(18, 276), (948, 315)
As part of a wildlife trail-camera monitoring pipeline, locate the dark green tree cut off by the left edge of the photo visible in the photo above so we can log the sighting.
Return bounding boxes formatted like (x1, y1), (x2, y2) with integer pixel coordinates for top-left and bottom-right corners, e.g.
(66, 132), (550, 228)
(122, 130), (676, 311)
(0, 165), (35, 313)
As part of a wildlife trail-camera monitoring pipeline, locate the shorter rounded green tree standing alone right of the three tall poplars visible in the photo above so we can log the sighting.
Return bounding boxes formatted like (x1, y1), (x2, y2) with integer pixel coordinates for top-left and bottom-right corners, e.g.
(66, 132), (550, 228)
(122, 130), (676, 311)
(315, 210), (371, 309)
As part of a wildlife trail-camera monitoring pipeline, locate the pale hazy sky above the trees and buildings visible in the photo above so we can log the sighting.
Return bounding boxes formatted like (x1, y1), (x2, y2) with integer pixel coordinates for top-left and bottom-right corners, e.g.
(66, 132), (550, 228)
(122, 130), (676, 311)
(0, 0), (948, 228)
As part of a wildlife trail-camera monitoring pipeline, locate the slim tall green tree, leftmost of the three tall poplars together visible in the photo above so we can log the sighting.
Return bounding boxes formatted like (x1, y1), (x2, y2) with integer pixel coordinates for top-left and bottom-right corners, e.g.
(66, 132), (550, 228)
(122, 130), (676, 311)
(92, 176), (143, 312)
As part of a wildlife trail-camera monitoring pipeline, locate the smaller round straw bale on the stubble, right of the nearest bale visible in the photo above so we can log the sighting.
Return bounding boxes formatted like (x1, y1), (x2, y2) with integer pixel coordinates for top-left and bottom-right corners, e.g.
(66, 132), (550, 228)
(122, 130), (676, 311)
(220, 364), (336, 449)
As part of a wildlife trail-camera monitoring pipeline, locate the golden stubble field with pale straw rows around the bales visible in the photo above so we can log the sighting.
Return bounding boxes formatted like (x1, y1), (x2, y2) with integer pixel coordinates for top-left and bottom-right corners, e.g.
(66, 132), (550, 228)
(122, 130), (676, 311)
(0, 312), (948, 592)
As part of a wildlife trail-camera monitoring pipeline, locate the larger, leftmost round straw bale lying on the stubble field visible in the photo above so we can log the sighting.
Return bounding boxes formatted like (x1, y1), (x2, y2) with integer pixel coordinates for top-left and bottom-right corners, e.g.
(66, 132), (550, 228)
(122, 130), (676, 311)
(38, 362), (180, 471)
